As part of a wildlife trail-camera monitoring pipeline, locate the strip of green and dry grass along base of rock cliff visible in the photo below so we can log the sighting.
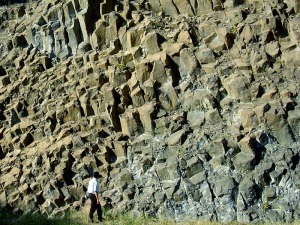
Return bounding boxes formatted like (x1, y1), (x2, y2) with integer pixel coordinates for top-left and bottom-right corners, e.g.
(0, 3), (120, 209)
(0, 211), (300, 225)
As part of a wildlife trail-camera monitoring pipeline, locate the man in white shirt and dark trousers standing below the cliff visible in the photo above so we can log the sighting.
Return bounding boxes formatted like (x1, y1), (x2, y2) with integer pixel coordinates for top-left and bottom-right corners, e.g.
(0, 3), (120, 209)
(88, 172), (102, 223)
